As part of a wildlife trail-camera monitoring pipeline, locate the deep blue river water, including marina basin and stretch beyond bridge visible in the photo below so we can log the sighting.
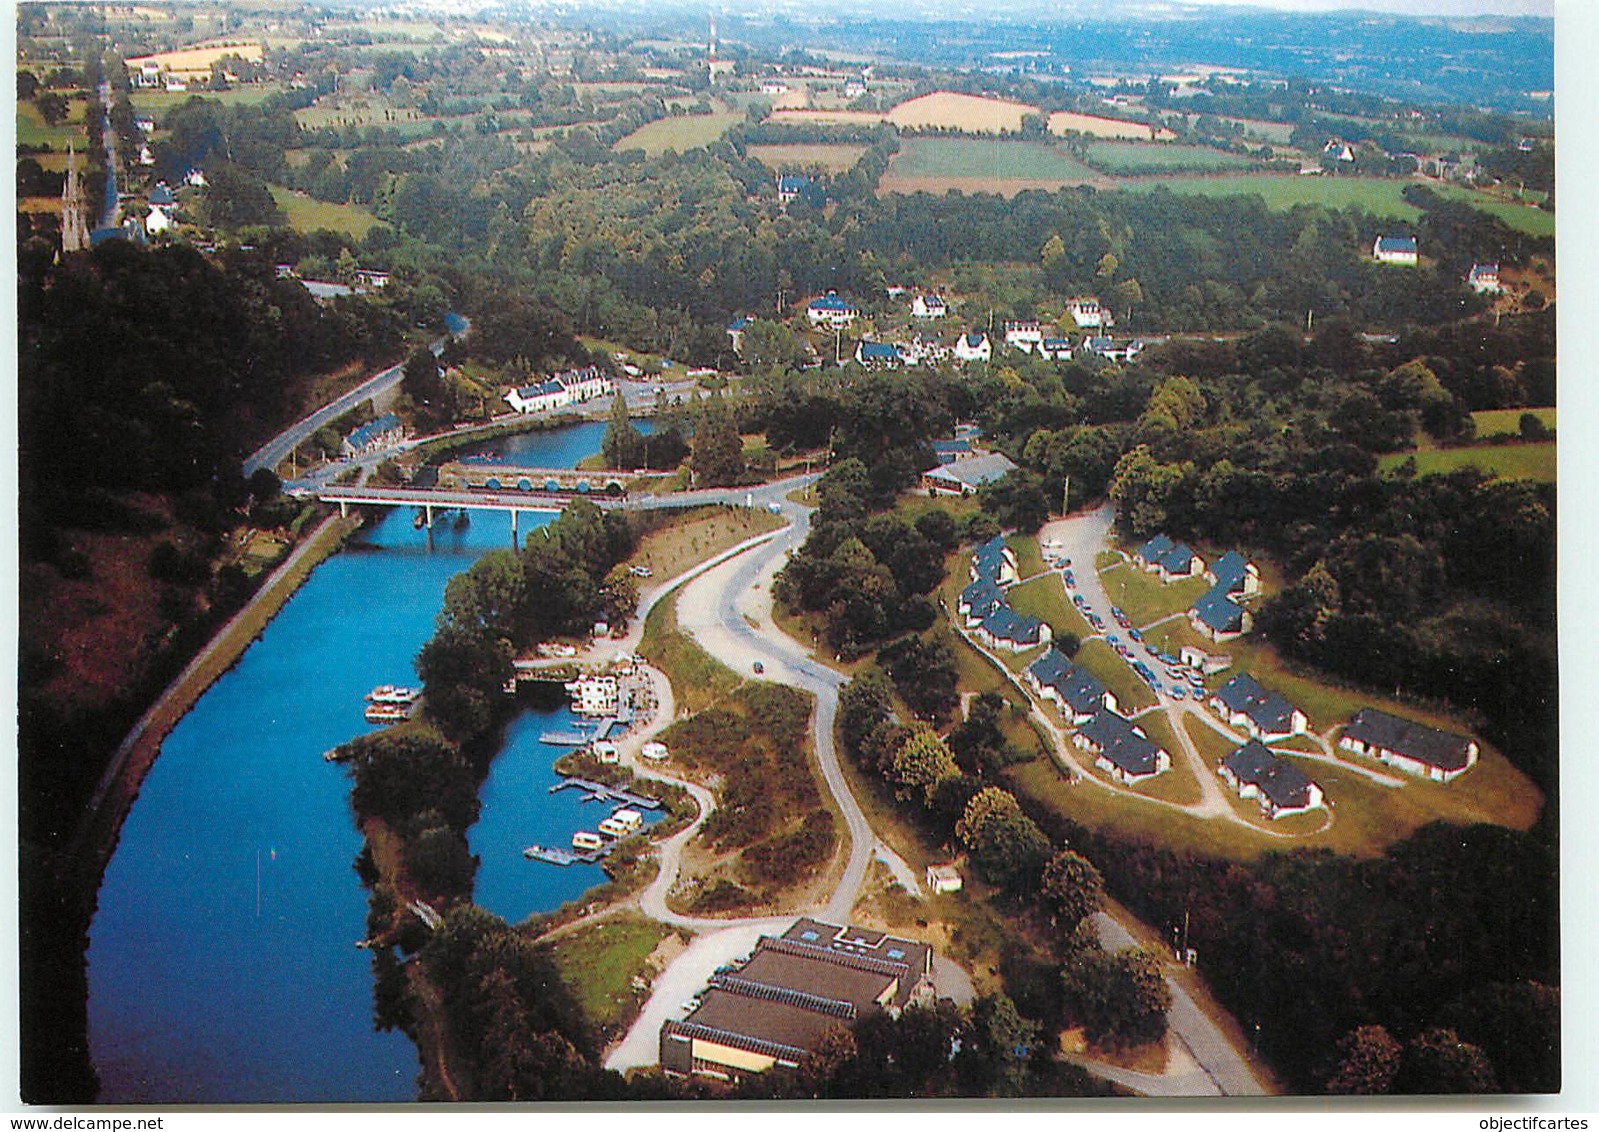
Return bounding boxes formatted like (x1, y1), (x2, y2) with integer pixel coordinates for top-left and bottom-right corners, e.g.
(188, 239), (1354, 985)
(88, 424), (636, 1103)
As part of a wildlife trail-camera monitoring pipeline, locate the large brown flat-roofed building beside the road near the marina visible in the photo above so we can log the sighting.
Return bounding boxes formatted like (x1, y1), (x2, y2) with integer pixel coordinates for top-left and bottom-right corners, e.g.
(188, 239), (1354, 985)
(660, 916), (932, 1081)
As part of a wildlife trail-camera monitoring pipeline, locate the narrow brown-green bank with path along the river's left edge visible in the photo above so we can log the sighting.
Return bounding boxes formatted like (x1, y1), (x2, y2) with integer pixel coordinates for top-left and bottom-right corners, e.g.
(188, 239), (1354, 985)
(61, 515), (361, 923)
